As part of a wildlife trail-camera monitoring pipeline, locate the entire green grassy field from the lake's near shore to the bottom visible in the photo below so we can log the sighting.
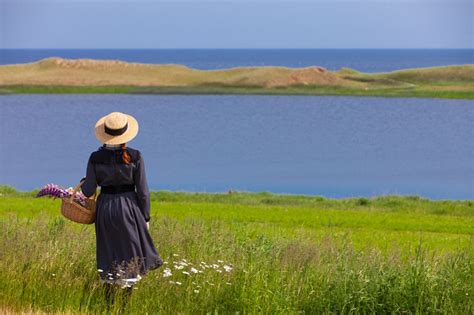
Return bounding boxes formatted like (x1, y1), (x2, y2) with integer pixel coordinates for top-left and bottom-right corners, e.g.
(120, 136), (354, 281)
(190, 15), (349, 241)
(0, 186), (474, 314)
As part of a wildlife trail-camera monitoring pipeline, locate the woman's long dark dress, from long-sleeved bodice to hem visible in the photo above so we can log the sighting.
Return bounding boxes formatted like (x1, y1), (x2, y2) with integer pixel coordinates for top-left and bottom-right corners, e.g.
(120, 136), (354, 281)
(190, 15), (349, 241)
(82, 146), (163, 284)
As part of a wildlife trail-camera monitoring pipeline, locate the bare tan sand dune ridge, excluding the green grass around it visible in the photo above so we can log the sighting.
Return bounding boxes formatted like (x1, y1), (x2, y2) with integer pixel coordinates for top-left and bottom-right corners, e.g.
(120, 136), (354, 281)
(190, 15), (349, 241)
(0, 58), (360, 88)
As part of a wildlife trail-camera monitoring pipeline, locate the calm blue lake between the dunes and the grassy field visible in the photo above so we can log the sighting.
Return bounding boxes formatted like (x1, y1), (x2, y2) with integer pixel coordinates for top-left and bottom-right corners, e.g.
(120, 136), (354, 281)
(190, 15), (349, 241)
(0, 95), (474, 199)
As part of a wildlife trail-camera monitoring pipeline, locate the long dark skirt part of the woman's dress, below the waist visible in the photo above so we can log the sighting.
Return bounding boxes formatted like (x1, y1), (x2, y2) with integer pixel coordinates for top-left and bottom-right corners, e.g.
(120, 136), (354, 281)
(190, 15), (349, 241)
(94, 192), (163, 284)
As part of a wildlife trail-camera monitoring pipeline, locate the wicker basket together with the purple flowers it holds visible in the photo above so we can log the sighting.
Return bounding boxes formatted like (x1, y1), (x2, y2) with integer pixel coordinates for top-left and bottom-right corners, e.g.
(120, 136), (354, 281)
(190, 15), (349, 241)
(36, 182), (96, 224)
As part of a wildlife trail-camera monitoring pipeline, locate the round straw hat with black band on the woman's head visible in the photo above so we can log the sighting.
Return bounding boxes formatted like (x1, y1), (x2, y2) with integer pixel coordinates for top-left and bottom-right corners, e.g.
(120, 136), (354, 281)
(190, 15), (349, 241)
(95, 112), (138, 144)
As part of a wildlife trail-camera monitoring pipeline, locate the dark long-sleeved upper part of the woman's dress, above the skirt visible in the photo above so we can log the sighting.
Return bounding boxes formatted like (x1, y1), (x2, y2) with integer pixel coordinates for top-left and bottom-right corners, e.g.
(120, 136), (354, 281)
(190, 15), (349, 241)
(81, 147), (150, 222)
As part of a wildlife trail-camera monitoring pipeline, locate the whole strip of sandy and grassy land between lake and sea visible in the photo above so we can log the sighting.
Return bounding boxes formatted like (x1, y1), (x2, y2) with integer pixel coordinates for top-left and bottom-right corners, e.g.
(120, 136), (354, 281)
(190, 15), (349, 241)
(0, 58), (474, 99)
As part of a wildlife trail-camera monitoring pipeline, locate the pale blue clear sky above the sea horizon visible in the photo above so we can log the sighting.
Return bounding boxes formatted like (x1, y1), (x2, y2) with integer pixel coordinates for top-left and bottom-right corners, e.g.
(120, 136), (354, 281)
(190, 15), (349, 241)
(0, 0), (474, 48)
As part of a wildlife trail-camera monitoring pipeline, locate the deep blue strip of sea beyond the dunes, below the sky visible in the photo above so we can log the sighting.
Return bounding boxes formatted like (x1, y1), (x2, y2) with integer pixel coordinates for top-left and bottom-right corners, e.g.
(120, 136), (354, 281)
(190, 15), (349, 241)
(0, 49), (474, 72)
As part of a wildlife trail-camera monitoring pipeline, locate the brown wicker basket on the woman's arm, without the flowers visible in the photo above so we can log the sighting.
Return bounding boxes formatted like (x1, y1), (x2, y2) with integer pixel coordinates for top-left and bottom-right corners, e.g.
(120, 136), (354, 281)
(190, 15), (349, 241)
(61, 182), (96, 224)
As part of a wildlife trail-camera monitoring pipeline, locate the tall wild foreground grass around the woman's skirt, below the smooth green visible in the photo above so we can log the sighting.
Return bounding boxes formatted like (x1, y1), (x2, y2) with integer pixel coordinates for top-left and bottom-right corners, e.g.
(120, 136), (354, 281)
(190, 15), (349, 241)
(0, 216), (474, 314)
